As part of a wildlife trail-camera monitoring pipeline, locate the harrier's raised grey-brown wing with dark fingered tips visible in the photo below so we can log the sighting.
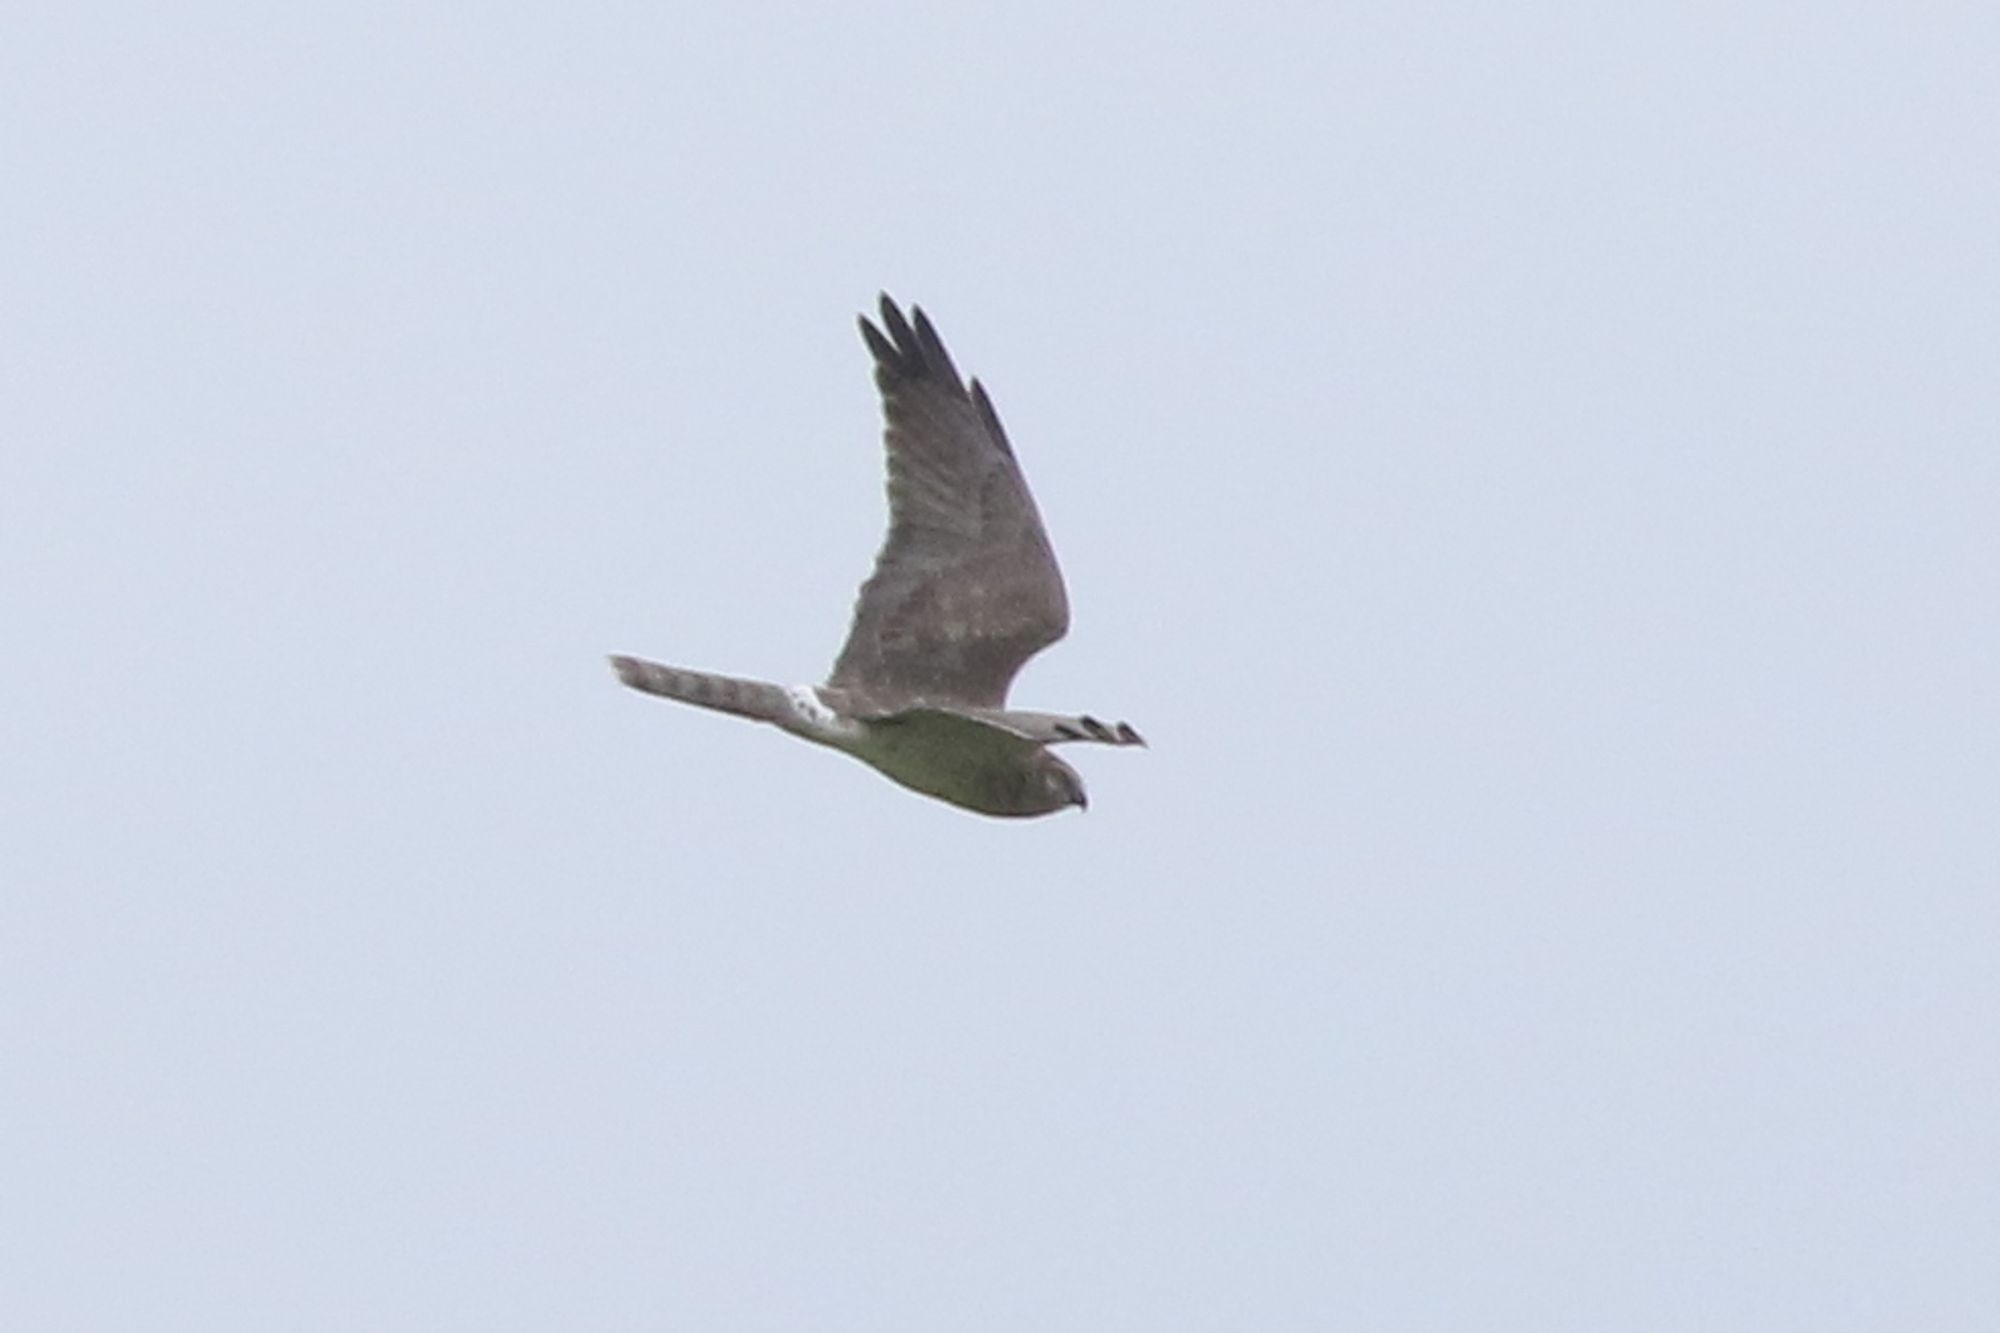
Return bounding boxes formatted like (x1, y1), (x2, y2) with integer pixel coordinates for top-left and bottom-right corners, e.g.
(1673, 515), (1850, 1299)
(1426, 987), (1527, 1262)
(828, 296), (1070, 709)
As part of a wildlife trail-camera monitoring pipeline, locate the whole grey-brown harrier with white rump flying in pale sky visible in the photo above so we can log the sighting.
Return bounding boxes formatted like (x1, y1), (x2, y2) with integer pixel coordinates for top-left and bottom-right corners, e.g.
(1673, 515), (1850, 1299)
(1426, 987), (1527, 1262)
(612, 296), (1144, 815)
